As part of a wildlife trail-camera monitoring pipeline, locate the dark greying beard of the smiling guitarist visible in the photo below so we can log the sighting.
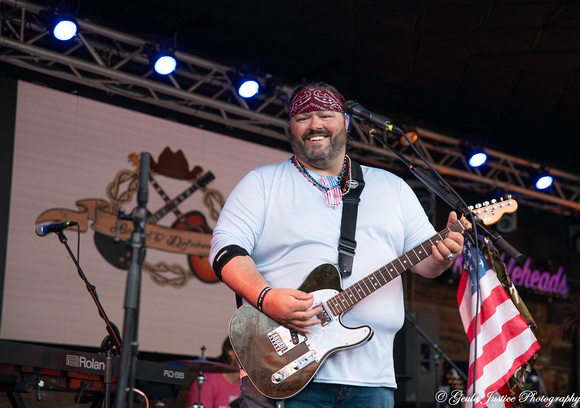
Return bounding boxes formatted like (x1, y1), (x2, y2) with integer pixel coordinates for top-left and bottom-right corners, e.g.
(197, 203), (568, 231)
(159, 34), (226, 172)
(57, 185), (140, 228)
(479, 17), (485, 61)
(290, 128), (347, 169)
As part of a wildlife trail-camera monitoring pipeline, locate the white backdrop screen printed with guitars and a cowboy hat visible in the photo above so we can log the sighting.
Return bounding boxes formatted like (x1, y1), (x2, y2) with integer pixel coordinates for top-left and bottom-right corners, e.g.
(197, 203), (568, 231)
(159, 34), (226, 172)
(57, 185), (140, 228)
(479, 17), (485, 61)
(0, 82), (289, 357)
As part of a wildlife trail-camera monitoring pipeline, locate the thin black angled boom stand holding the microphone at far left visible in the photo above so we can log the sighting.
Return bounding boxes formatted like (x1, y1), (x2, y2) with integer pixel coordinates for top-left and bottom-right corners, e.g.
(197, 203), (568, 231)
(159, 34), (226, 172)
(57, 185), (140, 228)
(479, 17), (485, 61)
(56, 230), (122, 408)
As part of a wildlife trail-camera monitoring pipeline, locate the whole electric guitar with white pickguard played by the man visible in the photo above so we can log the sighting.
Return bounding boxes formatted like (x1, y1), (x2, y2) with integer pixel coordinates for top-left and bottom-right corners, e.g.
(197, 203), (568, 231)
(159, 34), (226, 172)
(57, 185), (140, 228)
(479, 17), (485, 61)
(229, 199), (517, 399)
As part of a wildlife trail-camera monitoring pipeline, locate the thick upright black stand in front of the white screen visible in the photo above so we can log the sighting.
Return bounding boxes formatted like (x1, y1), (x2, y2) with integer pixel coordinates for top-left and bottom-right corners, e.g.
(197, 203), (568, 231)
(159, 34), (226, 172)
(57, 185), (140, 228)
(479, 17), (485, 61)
(115, 152), (151, 408)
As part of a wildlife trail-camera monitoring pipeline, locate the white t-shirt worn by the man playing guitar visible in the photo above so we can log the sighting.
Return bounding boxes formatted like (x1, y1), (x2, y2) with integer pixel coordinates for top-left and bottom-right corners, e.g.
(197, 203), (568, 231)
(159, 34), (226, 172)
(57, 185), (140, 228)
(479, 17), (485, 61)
(210, 160), (436, 388)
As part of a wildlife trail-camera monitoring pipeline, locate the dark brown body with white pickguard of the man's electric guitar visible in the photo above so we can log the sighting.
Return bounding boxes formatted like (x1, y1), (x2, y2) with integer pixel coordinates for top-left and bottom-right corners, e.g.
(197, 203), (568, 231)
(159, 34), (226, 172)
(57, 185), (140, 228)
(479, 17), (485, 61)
(229, 264), (373, 399)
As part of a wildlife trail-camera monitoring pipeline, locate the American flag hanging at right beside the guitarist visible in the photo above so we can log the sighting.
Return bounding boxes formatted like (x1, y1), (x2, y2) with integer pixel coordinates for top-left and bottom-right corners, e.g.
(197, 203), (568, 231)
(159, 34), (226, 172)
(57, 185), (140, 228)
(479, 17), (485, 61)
(457, 239), (540, 408)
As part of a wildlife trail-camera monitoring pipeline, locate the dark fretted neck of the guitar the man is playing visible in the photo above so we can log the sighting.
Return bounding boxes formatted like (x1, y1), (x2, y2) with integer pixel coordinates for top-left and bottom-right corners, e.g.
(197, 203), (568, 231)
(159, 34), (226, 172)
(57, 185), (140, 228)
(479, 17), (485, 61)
(327, 220), (466, 316)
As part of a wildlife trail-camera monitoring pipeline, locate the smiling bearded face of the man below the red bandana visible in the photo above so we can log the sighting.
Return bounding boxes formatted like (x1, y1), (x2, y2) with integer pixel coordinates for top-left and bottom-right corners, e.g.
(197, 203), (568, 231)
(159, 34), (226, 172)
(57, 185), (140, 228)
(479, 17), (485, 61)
(290, 111), (348, 169)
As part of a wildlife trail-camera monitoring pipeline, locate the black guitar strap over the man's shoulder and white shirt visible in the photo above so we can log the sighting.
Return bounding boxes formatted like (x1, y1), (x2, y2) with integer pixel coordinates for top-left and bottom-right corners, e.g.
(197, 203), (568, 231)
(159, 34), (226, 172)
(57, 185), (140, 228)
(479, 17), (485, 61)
(338, 159), (365, 277)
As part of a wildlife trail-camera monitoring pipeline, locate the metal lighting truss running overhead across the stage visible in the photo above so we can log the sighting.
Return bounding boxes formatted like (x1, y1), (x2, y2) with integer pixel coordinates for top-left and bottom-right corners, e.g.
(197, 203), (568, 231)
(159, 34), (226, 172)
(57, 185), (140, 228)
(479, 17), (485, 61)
(0, 0), (580, 216)
